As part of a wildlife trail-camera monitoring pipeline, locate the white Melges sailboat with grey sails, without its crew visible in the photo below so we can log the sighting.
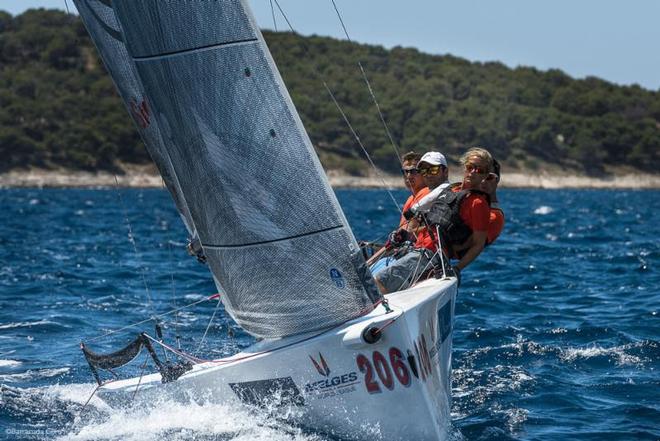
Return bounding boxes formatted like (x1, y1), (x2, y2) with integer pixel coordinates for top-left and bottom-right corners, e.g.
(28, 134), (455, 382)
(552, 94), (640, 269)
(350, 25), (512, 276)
(74, 0), (457, 440)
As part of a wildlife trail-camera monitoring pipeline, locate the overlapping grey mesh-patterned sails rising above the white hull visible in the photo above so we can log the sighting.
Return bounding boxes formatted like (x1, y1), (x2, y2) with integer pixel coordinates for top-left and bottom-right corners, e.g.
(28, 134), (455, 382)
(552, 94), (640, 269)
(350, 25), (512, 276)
(76, 0), (380, 338)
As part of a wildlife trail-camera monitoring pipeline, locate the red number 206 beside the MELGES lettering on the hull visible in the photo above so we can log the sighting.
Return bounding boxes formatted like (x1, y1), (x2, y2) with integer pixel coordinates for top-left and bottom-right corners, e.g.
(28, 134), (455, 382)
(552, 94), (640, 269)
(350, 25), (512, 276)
(355, 348), (411, 394)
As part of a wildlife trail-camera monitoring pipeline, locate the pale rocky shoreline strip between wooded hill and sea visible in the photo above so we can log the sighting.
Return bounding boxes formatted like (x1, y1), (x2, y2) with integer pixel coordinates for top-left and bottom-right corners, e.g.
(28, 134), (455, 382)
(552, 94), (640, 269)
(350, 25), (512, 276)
(0, 167), (660, 189)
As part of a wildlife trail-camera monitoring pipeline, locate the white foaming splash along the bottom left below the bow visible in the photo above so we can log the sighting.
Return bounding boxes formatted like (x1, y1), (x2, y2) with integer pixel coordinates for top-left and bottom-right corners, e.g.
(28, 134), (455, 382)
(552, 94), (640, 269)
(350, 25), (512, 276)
(1, 384), (326, 441)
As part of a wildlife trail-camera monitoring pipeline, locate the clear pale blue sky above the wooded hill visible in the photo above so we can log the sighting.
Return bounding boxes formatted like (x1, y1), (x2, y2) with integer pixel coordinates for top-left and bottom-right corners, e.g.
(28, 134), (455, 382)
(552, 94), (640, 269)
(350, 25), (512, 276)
(0, 0), (660, 90)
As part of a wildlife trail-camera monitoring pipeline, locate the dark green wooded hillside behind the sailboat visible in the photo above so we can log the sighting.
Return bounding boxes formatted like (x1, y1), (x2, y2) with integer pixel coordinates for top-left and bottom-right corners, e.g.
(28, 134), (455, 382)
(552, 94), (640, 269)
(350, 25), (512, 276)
(0, 10), (660, 174)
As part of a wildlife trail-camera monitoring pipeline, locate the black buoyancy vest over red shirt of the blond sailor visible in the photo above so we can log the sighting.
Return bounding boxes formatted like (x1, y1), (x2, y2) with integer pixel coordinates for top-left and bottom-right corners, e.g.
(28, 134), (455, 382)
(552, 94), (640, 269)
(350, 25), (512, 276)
(426, 186), (490, 246)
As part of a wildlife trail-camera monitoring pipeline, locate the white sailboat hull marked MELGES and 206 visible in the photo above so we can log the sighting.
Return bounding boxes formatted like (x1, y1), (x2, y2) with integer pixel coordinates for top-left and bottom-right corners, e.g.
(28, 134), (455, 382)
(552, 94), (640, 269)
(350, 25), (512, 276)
(98, 278), (457, 440)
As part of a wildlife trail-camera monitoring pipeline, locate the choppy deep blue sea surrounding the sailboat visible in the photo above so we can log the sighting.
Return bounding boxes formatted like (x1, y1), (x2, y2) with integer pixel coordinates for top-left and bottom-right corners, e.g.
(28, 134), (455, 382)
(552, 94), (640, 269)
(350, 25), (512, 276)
(0, 189), (660, 441)
